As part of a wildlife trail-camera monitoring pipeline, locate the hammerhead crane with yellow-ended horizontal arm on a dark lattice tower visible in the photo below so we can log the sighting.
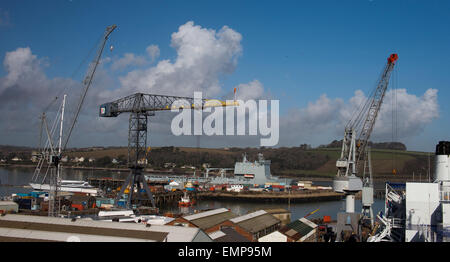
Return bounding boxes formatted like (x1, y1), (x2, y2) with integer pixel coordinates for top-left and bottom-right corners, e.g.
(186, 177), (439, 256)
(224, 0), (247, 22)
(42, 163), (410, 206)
(99, 93), (237, 209)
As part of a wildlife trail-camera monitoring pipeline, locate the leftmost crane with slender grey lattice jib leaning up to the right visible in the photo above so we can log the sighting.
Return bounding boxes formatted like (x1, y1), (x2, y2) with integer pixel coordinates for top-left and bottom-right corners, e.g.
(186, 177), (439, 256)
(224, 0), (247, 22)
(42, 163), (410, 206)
(32, 25), (117, 216)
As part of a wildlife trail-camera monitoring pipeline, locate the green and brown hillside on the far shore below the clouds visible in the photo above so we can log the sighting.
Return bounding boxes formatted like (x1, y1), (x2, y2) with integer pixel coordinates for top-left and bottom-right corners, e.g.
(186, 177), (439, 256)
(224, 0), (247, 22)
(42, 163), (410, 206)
(4, 145), (434, 180)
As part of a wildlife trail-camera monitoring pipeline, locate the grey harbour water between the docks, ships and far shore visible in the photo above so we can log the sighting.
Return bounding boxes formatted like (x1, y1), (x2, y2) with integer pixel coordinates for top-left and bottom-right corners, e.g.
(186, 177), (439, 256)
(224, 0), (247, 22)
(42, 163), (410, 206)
(0, 167), (384, 219)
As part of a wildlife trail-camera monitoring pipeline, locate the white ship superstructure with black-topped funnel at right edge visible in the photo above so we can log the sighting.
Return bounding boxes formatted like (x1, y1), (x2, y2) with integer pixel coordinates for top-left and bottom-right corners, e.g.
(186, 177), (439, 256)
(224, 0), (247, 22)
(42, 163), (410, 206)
(369, 141), (450, 242)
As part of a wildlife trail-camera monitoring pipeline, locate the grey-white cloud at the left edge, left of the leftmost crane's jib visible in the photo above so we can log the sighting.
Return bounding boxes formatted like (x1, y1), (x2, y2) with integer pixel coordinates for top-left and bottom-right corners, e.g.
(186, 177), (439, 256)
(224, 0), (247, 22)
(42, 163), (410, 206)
(0, 47), (77, 145)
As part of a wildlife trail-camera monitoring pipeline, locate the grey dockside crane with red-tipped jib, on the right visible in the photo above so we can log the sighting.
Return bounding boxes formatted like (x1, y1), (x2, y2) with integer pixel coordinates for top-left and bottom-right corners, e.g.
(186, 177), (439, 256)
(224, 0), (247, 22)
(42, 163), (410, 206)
(333, 54), (398, 237)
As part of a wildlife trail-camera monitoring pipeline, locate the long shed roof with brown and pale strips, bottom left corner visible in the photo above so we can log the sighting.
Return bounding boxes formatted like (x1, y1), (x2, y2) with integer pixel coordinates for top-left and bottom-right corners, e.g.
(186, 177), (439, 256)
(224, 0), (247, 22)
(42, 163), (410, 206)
(0, 215), (212, 242)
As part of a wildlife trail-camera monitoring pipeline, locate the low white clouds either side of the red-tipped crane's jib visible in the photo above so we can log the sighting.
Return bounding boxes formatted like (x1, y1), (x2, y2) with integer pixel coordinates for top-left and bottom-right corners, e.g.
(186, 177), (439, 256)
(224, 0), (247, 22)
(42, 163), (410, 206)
(280, 88), (439, 145)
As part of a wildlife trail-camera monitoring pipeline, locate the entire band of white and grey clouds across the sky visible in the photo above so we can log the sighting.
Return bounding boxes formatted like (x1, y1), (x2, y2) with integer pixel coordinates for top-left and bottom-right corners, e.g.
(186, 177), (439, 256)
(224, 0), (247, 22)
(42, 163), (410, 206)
(0, 22), (439, 150)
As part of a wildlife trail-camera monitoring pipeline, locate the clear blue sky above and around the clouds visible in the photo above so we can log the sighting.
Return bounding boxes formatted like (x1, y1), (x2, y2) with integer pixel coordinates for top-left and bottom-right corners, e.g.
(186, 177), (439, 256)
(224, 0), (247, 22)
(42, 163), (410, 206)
(0, 0), (450, 151)
